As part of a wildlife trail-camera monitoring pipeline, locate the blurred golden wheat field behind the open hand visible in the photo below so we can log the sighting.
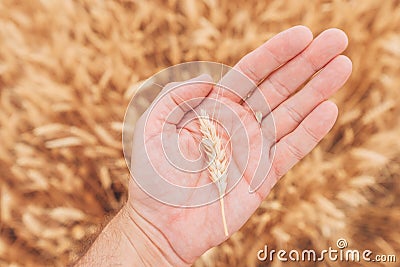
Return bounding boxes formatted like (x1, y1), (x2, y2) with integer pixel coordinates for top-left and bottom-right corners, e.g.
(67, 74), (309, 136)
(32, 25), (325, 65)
(0, 0), (400, 266)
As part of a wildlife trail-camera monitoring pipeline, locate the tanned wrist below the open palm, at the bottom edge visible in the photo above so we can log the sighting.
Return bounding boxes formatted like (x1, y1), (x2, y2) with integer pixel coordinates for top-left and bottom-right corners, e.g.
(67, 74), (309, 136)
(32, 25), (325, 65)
(76, 204), (189, 266)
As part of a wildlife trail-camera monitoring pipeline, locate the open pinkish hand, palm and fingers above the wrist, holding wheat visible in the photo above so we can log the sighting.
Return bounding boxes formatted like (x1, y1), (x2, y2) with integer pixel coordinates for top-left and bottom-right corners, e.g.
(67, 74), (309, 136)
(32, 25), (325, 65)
(128, 26), (351, 263)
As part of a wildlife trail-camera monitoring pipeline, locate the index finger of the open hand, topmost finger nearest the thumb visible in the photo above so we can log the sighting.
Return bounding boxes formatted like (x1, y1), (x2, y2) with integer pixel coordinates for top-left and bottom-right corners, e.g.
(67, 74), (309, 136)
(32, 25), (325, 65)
(215, 26), (313, 102)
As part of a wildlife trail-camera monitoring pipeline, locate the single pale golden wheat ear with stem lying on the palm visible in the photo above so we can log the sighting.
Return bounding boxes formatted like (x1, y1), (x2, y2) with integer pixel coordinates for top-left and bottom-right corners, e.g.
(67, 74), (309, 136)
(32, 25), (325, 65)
(199, 109), (228, 236)
